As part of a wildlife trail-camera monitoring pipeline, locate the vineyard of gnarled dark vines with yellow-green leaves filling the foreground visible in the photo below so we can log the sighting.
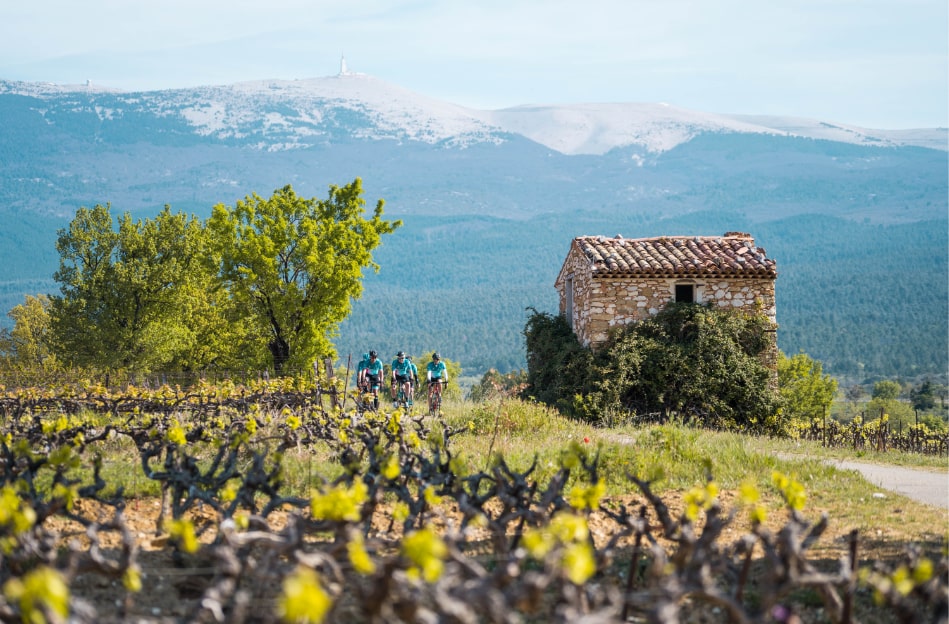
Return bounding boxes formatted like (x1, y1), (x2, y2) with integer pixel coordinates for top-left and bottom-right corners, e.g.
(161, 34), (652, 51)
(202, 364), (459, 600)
(0, 379), (949, 624)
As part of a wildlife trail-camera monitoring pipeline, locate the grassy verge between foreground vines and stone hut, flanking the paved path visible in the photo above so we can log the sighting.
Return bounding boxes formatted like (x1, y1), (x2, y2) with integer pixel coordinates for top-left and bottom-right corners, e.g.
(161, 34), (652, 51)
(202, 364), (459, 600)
(434, 400), (949, 557)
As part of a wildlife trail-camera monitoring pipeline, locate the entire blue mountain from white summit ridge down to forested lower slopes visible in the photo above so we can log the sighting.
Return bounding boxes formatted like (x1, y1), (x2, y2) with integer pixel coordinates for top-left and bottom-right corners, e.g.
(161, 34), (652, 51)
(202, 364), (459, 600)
(0, 73), (949, 376)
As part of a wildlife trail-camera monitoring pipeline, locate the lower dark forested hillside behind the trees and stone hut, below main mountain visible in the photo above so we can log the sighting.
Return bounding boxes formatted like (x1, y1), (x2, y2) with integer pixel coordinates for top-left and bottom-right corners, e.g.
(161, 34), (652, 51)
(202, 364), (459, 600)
(0, 185), (949, 379)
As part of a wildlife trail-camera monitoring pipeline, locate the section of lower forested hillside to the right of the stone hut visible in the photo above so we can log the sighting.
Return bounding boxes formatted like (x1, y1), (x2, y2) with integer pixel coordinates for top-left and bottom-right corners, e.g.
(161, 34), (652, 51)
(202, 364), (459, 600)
(759, 216), (949, 379)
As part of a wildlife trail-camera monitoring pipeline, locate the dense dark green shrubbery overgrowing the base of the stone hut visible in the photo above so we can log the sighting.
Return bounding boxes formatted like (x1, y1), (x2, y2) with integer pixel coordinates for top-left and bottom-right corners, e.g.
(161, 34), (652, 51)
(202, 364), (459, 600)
(524, 303), (787, 434)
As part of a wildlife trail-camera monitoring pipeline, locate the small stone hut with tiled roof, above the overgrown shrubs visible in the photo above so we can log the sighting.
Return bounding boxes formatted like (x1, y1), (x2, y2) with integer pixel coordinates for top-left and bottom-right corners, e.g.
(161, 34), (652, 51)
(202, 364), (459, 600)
(555, 232), (777, 360)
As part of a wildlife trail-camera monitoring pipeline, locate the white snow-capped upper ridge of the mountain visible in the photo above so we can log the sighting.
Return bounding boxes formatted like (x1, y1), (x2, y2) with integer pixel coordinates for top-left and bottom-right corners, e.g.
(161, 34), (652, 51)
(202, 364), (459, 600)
(0, 72), (949, 155)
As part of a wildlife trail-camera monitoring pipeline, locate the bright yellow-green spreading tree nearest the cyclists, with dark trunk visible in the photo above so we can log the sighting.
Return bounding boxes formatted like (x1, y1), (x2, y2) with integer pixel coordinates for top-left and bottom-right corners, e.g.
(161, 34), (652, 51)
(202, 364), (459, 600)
(208, 178), (402, 374)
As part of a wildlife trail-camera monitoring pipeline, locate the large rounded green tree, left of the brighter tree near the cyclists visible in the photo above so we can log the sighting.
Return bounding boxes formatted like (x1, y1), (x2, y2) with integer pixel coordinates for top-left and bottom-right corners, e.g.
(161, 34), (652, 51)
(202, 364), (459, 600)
(50, 205), (220, 372)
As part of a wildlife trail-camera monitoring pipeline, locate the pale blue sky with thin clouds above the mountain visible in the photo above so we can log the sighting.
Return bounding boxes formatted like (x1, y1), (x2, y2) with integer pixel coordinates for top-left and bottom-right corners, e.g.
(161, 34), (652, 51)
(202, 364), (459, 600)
(0, 0), (949, 129)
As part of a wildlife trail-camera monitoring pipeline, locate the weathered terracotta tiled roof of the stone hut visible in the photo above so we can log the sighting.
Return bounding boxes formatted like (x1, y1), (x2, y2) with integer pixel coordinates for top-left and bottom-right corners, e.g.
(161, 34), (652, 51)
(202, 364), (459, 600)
(574, 232), (778, 279)
